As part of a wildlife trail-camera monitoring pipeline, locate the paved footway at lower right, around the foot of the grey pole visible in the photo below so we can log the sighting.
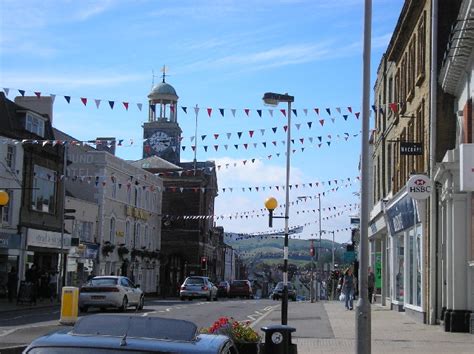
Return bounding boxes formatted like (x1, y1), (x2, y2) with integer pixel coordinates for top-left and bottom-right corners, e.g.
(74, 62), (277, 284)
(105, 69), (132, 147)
(254, 301), (474, 354)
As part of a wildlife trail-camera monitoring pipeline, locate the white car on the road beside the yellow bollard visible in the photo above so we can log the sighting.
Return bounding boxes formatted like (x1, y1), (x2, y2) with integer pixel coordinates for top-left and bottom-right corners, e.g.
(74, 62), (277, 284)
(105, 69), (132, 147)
(79, 276), (145, 312)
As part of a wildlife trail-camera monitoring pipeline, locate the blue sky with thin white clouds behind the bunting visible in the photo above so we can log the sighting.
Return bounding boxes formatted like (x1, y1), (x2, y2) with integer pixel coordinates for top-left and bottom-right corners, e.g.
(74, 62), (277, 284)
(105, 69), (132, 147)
(0, 0), (403, 242)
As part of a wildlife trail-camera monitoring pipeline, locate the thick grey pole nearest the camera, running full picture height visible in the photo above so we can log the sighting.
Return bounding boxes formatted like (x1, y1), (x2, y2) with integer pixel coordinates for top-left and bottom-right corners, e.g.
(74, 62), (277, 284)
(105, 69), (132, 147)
(355, 0), (372, 354)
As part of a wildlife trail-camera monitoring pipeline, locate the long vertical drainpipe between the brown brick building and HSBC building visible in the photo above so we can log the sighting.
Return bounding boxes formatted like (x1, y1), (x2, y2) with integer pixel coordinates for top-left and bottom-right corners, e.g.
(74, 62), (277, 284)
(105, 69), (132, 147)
(428, 0), (438, 325)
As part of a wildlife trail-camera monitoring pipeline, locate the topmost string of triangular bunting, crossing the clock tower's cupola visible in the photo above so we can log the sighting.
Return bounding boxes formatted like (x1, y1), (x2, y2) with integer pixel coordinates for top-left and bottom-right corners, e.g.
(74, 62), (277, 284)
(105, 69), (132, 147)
(3, 87), (360, 119)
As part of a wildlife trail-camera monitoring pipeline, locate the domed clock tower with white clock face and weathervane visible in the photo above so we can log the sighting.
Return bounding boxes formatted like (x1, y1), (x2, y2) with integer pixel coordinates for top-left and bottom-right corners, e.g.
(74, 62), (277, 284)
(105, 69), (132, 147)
(143, 73), (182, 164)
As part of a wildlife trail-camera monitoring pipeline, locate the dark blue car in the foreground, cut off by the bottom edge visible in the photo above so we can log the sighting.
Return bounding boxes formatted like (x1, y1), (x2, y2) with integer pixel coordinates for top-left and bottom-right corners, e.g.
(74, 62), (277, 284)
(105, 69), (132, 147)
(23, 314), (237, 354)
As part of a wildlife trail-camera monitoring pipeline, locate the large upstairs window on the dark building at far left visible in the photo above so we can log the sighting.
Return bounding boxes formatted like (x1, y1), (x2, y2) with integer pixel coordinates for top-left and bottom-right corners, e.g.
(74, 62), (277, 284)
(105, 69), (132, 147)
(31, 165), (56, 213)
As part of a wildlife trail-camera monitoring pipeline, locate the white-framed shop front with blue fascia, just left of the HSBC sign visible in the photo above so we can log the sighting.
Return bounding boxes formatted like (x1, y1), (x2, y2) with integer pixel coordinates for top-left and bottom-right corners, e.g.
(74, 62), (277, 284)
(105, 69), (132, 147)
(385, 192), (426, 322)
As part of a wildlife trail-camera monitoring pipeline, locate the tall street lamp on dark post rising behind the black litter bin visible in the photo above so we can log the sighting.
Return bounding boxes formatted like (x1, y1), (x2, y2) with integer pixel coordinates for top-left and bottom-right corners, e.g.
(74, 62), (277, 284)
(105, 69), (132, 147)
(263, 92), (295, 325)
